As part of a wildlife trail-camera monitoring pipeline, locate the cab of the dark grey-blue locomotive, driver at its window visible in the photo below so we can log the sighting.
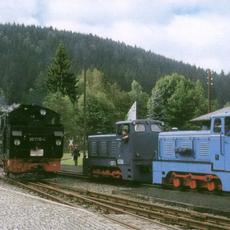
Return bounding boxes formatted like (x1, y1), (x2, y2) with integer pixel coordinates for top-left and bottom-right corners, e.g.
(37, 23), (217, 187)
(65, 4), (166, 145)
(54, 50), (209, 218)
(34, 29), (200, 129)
(116, 119), (161, 182)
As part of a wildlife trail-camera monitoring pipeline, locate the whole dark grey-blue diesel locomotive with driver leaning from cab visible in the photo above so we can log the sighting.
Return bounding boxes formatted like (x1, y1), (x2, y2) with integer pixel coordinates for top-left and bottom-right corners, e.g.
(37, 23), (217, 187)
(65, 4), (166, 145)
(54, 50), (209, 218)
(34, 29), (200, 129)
(83, 119), (161, 182)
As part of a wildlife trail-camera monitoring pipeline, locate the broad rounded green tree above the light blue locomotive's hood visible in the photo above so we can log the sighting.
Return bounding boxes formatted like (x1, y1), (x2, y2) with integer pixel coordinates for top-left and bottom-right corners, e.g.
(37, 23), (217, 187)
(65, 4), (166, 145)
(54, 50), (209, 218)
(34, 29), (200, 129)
(148, 74), (207, 129)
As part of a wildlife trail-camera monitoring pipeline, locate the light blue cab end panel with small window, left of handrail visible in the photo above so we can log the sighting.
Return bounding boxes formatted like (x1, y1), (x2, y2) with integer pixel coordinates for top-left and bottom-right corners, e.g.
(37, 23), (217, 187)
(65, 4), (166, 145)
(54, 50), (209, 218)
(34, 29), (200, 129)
(210, 117), (225, 170)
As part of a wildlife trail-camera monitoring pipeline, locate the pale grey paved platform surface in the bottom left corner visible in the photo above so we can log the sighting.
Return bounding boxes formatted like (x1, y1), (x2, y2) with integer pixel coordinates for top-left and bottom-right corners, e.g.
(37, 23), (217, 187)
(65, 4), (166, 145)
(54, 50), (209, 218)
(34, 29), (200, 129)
(0, 183), (126, 230)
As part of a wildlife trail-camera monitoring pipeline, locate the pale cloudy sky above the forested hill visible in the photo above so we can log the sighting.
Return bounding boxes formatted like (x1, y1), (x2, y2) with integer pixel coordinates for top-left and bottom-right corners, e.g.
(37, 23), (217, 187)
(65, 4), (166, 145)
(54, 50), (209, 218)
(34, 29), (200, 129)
(0, 0), (230, 73)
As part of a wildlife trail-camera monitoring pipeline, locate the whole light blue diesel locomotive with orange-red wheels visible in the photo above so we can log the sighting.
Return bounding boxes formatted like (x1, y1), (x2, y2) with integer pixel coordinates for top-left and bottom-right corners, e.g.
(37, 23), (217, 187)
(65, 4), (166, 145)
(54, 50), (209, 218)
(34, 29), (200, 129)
(152, 113), (230, 192)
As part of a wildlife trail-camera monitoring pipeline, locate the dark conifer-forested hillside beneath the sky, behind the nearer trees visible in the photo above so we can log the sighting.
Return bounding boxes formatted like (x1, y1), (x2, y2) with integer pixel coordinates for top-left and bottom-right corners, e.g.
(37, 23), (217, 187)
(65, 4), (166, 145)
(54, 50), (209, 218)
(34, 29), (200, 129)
(0, 24), (230, 106)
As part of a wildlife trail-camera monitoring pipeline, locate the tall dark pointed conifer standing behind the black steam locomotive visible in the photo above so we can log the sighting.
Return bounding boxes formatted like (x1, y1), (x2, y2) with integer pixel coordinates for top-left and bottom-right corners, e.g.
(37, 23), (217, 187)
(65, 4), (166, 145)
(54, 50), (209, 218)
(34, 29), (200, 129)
(47, 44), (76, 103)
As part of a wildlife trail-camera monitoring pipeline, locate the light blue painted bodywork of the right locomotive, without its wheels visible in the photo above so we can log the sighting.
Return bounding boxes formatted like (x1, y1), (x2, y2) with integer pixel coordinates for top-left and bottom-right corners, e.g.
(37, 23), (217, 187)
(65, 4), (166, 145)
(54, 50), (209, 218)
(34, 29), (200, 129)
(152, 113), (230, 191)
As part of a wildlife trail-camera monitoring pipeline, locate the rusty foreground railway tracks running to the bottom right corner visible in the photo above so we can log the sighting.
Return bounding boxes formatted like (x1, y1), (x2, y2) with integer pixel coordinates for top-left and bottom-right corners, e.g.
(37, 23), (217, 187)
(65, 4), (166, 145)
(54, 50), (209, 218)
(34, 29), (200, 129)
(10, 179), (230, 230)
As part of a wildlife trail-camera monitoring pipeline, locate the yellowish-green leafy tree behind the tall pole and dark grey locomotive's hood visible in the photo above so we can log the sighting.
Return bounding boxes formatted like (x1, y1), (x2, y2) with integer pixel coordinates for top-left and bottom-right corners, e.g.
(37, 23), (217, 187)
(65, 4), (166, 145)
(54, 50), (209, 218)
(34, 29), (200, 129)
(76, 69), (115, 135)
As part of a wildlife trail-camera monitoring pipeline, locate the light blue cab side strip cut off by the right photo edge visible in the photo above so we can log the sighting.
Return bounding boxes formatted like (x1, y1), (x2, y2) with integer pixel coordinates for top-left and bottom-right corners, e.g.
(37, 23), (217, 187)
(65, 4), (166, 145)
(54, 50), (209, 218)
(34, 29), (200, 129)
(223, 117), (230, 171)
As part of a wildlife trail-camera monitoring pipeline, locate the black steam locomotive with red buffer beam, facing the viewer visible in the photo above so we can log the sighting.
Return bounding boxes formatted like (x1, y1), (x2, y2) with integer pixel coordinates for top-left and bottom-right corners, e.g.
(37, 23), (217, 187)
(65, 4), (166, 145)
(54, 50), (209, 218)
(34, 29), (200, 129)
(0, 105), (64, 174)
